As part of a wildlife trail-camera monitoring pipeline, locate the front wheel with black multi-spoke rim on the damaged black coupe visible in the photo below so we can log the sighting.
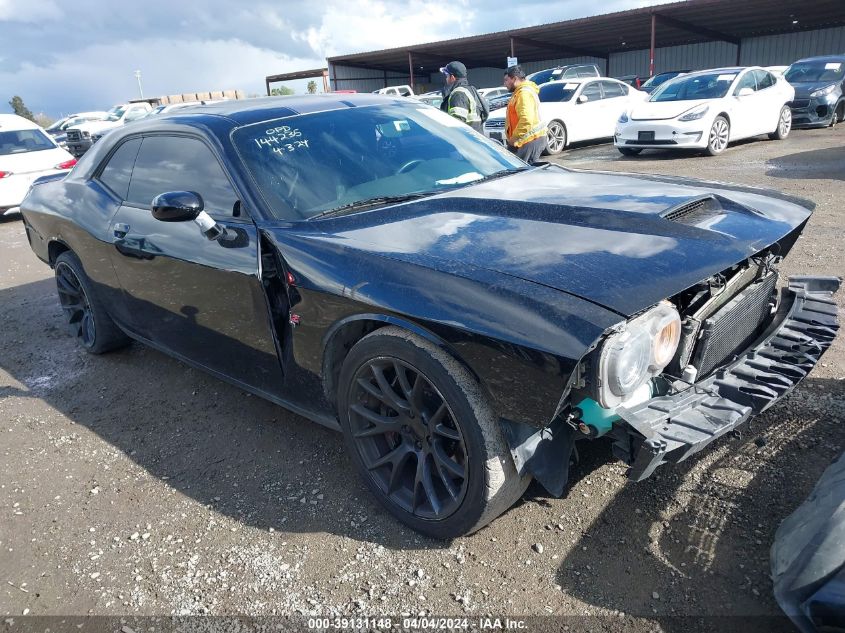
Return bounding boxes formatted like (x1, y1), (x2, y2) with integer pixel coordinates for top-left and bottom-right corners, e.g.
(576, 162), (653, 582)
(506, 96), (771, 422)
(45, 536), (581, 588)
(338, 327), (530, 538)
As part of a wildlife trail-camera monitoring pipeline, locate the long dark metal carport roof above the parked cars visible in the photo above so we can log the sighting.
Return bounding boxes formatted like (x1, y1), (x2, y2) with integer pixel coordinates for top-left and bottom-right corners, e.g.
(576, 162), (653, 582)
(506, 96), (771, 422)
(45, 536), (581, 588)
(328, 0), (845, 72)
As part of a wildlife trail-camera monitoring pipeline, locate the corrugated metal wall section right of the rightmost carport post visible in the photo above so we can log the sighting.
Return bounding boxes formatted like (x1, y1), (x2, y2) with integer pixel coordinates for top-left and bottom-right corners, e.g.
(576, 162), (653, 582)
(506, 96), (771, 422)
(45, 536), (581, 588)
(741, 27), (845, 66)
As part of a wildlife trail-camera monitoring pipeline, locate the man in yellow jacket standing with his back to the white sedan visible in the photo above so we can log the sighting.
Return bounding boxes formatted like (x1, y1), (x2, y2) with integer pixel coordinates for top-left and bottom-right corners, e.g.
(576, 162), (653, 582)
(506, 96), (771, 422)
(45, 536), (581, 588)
(504, 66), (546, 163)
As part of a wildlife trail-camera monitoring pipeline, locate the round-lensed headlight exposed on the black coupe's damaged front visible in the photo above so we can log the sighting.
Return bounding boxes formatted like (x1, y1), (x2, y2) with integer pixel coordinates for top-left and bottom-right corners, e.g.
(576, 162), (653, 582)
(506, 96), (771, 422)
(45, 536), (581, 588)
(596, 303), (681, 409)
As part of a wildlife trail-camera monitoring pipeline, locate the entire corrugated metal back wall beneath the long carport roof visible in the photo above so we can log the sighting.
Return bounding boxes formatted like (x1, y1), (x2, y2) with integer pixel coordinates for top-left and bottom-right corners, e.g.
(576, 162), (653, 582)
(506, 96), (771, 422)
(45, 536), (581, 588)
(329, 26), (845, 93)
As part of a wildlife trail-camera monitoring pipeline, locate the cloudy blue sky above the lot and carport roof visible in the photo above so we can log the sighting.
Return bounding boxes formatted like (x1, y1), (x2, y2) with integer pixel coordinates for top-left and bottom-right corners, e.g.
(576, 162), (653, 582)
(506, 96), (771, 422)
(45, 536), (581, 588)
(0, 0), (666, 118)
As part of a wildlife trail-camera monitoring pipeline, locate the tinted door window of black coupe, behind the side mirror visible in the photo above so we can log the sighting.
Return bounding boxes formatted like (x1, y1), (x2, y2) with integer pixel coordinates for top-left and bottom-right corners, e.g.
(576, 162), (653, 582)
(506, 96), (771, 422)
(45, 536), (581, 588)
(127, 136), (237, 218)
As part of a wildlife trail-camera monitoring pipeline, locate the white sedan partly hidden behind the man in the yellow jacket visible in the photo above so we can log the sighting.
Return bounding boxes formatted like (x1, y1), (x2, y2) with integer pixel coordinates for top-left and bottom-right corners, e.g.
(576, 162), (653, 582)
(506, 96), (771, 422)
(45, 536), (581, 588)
(484, 77), (648, 155)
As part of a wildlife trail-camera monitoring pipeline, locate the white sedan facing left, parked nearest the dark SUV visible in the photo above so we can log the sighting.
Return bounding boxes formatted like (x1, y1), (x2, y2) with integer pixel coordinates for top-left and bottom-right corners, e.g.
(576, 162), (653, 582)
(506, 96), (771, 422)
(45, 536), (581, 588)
(613, 67), (795, 156)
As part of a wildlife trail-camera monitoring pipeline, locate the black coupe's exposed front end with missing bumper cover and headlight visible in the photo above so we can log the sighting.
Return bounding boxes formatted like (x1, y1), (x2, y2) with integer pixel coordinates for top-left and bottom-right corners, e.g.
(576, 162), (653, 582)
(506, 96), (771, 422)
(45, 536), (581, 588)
(504, 242), (841, 496)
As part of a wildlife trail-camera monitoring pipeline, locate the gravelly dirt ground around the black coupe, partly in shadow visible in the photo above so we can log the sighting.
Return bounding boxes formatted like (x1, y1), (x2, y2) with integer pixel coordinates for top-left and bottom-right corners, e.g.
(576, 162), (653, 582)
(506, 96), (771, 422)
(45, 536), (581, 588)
(0, 126), (845, 631)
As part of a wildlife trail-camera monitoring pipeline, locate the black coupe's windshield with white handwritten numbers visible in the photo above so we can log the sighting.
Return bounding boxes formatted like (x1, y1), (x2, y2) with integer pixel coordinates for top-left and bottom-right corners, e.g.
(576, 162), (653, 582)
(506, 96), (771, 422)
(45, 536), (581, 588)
(232, 104), (526, 220)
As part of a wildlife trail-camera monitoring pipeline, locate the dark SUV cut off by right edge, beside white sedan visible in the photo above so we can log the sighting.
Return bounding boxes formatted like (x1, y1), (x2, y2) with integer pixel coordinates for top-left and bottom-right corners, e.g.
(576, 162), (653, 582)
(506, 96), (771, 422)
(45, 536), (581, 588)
(784, 55), (845, 127)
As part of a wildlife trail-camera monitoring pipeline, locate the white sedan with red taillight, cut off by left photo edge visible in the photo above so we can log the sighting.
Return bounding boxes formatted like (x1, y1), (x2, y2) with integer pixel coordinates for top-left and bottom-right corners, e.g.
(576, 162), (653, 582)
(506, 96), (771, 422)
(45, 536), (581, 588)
(0, 114), (76, 215)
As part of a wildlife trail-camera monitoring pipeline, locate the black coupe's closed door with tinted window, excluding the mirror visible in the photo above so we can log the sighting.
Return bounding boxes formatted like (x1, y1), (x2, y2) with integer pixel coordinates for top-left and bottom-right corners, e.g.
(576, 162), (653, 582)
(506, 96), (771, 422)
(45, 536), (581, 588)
(104, 135), (283, 396)
